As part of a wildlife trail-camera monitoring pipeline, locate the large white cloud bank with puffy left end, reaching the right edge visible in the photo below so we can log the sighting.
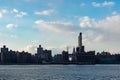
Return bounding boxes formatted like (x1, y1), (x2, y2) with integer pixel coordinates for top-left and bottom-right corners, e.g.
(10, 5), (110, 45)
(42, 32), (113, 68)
(79, 14), (120, 34)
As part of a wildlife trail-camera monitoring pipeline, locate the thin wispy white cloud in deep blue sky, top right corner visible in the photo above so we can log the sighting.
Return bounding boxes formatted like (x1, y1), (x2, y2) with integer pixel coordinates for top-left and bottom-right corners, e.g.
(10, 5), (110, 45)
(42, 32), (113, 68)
(92, 1), (115, 7)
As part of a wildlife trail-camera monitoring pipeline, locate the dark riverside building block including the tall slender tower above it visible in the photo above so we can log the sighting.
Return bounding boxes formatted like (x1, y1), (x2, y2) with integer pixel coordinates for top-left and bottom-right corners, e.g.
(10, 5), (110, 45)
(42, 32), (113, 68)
(72, 33), (95, 64)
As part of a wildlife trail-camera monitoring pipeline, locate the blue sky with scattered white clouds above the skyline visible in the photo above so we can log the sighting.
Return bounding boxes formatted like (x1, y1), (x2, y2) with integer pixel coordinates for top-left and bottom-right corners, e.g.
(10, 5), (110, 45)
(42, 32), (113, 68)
(0, 0), (120, 54)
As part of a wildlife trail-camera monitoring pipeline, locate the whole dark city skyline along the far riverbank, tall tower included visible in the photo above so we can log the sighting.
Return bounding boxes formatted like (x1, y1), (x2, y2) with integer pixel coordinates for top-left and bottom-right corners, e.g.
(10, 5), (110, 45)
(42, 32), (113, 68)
(0, 32), (120, 64)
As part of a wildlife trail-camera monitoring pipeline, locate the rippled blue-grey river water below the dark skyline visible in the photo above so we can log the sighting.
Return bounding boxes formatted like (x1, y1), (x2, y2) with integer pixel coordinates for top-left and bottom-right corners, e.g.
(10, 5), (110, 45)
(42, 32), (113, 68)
(0, 65), (120, 80)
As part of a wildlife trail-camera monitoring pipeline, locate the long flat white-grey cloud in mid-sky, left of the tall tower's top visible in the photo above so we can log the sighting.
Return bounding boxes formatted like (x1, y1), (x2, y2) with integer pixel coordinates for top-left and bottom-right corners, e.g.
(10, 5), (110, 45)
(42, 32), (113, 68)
(35, 20), (75, 32)
